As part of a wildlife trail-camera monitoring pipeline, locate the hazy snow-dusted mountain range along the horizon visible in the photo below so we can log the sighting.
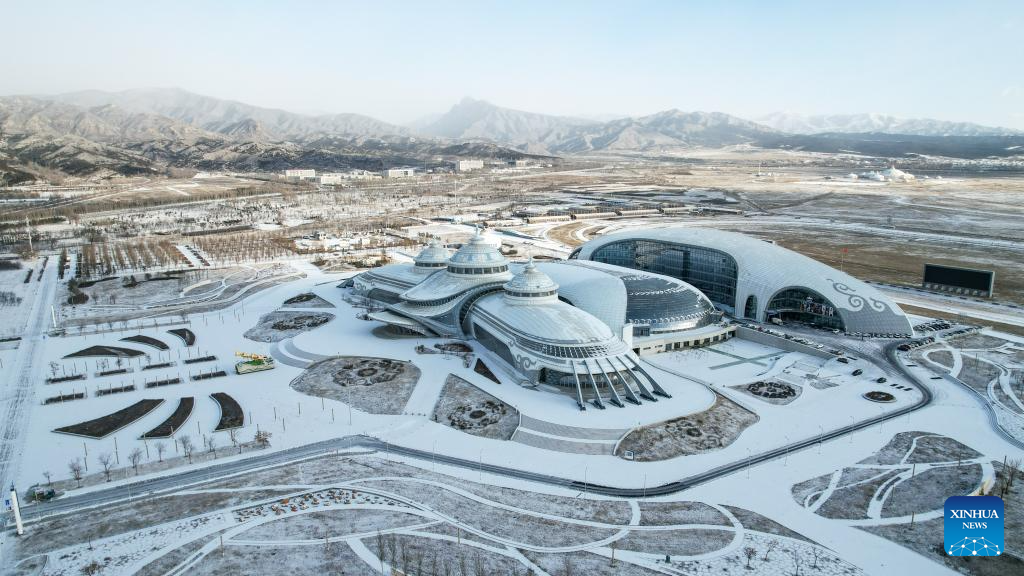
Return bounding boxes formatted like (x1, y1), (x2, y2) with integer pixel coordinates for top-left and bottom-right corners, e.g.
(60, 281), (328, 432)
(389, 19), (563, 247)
(0, 88), (1024, 183)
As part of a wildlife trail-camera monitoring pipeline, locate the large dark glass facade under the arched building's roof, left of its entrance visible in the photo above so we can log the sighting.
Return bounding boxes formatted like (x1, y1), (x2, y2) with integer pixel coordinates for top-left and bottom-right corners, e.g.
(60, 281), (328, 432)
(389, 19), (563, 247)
(590, 240), (738, 310)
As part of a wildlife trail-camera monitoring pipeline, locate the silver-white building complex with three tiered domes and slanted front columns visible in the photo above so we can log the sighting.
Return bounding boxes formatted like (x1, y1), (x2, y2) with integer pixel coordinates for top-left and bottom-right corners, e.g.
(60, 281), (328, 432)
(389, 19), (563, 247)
(352, 229), (734, 409)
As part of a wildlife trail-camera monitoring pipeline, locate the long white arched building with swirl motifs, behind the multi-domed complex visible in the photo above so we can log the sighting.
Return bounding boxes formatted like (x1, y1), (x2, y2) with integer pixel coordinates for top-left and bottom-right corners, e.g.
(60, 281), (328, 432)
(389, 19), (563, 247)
(569, 227), (913, 338)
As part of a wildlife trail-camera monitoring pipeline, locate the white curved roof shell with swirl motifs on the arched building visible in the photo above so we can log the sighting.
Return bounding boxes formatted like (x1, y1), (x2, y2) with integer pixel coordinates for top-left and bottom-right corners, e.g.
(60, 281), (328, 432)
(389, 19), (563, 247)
(578, 227), (913, 334)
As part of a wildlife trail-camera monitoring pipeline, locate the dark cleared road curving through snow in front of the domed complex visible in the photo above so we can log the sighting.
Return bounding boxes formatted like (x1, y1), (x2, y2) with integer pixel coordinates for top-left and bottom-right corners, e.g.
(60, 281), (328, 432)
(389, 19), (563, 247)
(8, 342), (932, 522)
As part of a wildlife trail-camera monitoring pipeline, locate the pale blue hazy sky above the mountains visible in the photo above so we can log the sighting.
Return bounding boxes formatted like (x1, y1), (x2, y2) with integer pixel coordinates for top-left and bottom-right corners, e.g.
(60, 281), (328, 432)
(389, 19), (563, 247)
(0, 0), (1024, 129)
